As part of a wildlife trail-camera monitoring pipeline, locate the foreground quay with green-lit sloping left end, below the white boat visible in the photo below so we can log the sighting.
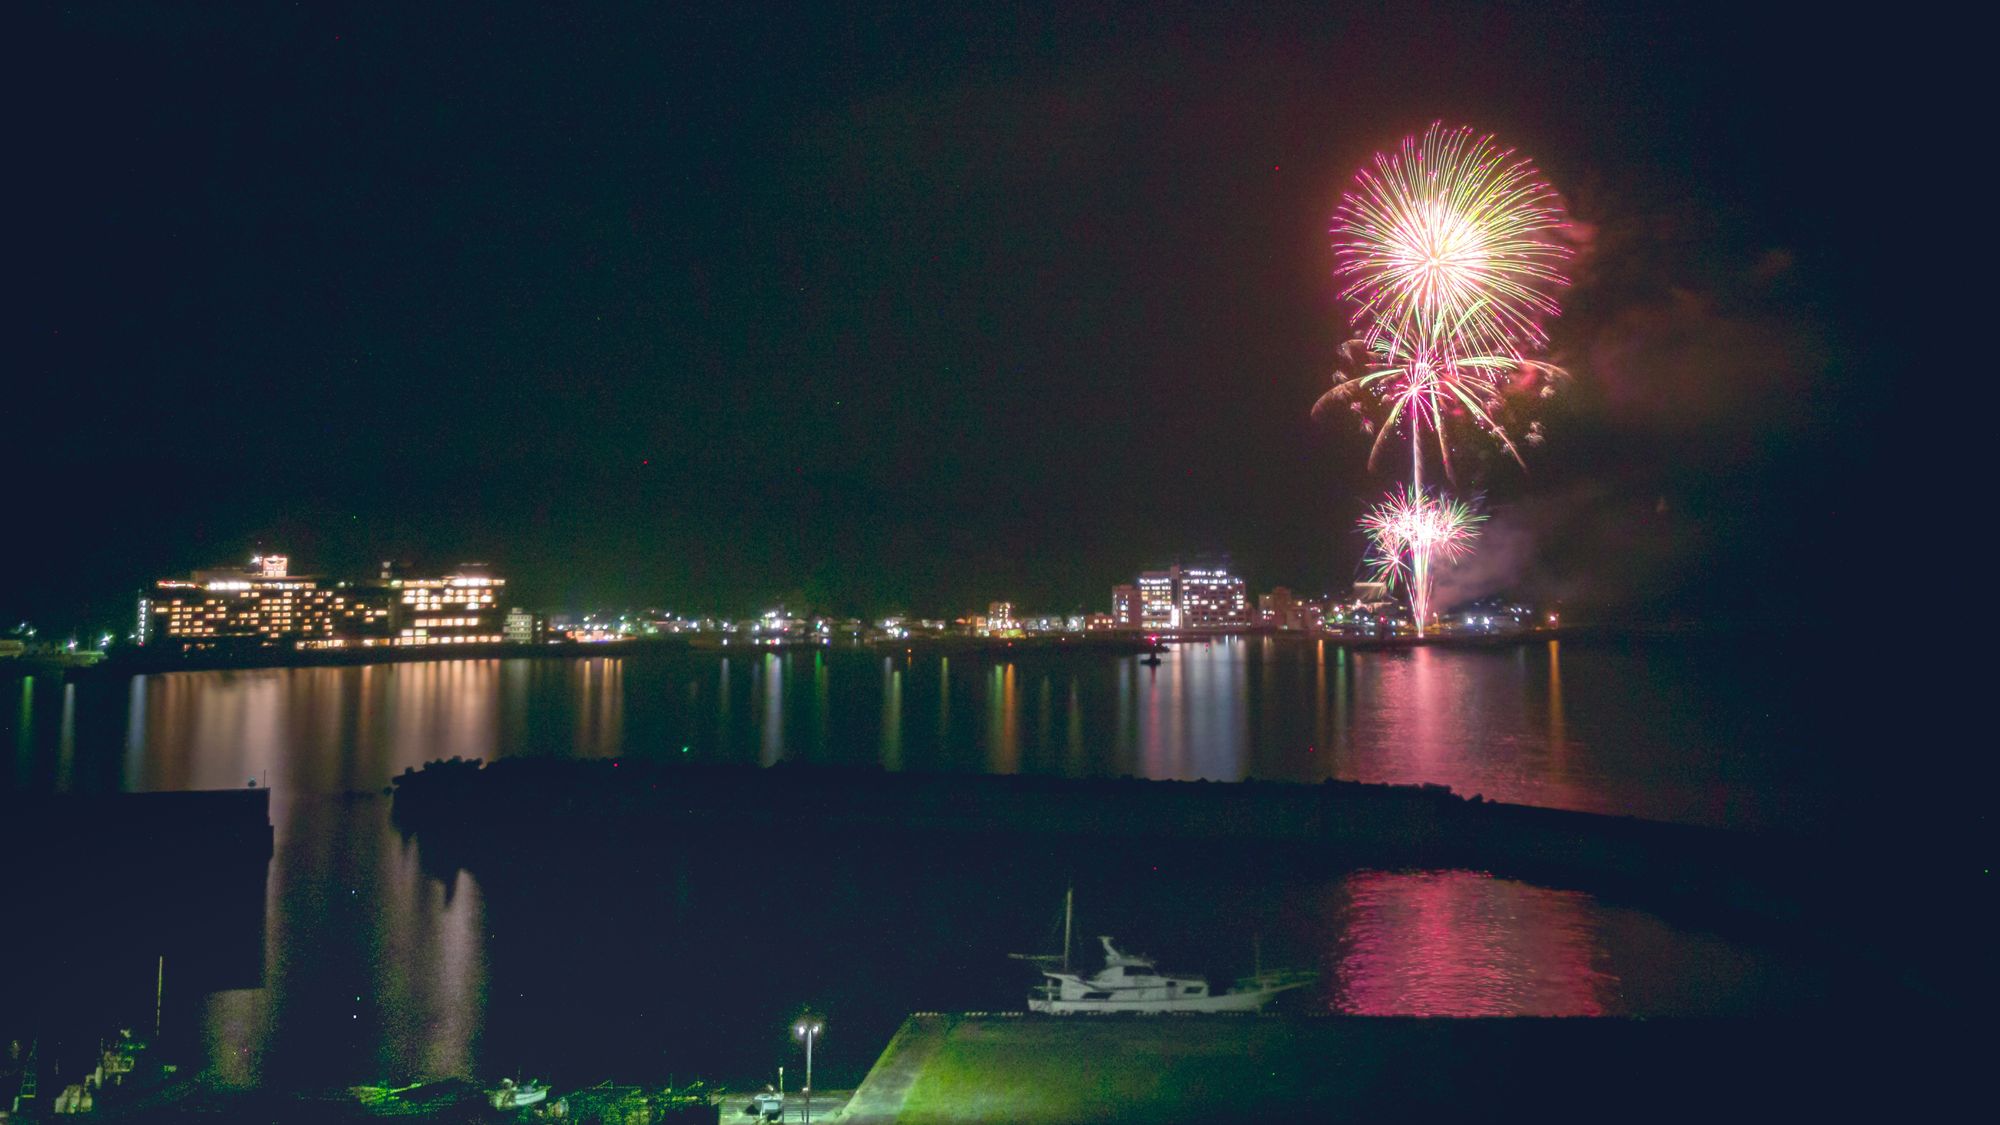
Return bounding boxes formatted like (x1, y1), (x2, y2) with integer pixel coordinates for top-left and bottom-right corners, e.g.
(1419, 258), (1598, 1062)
(842, 1013), (1976, 1125)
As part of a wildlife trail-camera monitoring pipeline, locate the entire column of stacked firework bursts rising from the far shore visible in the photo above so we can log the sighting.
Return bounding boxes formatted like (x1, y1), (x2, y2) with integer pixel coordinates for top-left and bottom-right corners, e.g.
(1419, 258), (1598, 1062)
(1312, 122), (1570, 637)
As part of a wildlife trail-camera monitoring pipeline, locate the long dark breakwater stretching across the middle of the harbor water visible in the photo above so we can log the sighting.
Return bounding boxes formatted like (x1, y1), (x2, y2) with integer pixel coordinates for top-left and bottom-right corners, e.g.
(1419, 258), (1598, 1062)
(382, 759), (1818, 923)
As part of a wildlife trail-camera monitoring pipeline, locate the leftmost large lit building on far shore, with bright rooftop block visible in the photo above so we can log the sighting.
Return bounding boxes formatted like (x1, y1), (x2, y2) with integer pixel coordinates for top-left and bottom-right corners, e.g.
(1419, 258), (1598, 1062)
(138, 554), (390, 651)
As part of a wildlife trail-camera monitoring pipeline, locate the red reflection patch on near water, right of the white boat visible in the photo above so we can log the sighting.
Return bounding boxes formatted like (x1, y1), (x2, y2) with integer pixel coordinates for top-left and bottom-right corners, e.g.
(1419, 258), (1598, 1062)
(1326, 871), (1620, 1015)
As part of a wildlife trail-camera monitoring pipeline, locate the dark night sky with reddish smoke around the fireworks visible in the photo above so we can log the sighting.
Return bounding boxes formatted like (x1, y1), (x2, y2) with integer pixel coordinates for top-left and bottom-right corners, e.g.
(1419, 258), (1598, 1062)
(15, 4), (1890, 629)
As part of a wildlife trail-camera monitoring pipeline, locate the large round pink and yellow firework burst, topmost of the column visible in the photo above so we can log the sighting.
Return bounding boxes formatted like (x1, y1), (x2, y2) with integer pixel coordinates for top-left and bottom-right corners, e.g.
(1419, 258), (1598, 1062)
(1334, 122), (1570, 358)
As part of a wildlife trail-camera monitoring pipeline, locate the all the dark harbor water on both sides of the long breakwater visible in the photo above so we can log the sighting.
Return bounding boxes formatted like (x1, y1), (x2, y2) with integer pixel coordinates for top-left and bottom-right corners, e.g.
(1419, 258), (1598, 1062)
(0, 639), (1842, 1085)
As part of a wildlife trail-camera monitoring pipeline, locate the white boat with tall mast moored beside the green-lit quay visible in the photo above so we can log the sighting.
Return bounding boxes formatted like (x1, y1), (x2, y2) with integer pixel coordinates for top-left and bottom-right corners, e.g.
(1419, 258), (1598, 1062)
(1016, 899), (1318, 1015)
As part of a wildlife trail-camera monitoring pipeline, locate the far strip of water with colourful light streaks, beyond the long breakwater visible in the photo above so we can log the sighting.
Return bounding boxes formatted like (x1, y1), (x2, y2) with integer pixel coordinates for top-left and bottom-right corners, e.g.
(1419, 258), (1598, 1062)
(0, 639), (1800, 823)
